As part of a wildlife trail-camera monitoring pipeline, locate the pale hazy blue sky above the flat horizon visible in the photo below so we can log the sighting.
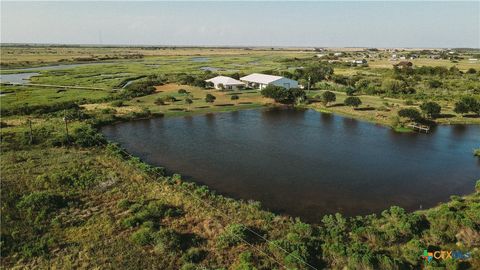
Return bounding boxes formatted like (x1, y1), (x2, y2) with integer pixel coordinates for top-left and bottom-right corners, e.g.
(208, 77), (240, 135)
(0, 1), (480, 48)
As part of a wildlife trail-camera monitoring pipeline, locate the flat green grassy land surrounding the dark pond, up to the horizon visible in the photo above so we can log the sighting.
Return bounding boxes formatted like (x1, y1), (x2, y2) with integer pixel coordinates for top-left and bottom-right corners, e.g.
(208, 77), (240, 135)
(0, 45), (480, 270)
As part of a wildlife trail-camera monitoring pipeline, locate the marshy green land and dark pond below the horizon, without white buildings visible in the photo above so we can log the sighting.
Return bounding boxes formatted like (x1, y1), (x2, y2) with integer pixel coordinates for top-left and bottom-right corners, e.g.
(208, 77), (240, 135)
(0, 45), (480, 269)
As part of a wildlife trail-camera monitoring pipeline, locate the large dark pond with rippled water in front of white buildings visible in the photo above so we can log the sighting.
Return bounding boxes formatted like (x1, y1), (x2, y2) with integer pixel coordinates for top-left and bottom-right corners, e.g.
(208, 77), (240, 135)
(99, 109), (480, 222)
